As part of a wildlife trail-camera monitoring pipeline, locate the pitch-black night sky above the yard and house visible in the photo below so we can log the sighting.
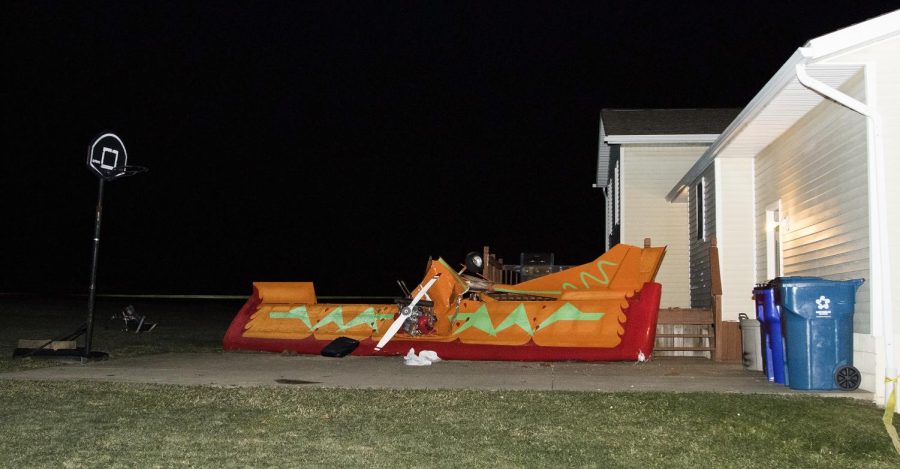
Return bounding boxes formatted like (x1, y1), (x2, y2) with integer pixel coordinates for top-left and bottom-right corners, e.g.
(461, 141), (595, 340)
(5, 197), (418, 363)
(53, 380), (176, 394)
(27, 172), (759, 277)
(0, 1), (900, 294)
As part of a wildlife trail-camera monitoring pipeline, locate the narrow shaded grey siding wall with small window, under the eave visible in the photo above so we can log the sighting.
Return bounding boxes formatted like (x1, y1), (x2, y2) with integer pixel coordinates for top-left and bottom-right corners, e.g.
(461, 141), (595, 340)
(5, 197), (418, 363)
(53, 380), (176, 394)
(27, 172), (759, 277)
(687, 166), (716, 308)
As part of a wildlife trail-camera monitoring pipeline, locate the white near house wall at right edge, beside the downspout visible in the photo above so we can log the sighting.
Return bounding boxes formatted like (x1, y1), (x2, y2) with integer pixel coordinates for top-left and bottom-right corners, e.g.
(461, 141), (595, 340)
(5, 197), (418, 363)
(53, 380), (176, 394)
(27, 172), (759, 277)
(828, 33), (900, 410)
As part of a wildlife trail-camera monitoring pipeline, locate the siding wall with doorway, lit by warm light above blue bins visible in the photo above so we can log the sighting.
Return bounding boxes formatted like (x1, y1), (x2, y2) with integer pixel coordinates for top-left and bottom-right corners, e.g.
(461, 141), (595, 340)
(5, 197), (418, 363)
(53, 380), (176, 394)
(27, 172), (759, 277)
(756, 74), (870, 333)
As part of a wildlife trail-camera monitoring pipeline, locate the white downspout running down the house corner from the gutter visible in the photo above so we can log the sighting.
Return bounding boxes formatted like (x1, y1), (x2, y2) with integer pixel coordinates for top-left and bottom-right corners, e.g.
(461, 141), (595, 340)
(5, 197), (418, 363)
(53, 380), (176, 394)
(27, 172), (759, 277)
(797, 63), (897, 410)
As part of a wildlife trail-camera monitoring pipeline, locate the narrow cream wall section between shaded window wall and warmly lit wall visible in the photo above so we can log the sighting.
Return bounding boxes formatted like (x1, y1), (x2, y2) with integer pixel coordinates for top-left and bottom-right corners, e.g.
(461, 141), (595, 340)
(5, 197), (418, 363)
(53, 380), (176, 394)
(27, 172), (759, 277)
(715, 158), (756, 321)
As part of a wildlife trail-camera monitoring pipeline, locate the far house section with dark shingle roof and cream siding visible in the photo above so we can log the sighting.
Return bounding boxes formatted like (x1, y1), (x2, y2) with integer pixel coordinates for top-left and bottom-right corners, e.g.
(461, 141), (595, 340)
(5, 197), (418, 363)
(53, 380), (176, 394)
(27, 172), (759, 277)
(596, 109), (738, 307)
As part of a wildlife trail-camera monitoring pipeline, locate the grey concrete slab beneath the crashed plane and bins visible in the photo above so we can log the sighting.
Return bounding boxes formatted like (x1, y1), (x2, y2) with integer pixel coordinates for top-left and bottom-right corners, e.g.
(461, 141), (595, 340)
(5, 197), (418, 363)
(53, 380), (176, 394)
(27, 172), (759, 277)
(0, 352), (872, 400)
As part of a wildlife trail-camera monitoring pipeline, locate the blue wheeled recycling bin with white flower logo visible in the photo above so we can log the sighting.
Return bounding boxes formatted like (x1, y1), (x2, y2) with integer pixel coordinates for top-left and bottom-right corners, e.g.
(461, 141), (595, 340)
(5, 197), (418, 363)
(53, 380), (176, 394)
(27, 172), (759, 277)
(771, 277), (864, 391)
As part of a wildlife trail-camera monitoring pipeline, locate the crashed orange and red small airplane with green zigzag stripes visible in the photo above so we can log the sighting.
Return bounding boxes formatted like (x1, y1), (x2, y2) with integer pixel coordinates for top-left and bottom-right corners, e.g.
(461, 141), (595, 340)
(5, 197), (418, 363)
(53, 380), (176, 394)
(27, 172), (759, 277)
(224, 244), (665, 361)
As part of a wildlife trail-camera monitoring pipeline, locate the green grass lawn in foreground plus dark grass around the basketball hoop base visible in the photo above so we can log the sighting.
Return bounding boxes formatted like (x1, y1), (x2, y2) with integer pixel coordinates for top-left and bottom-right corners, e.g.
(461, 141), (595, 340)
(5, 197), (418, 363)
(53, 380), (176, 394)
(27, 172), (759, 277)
(0, 302), (900, 468)
